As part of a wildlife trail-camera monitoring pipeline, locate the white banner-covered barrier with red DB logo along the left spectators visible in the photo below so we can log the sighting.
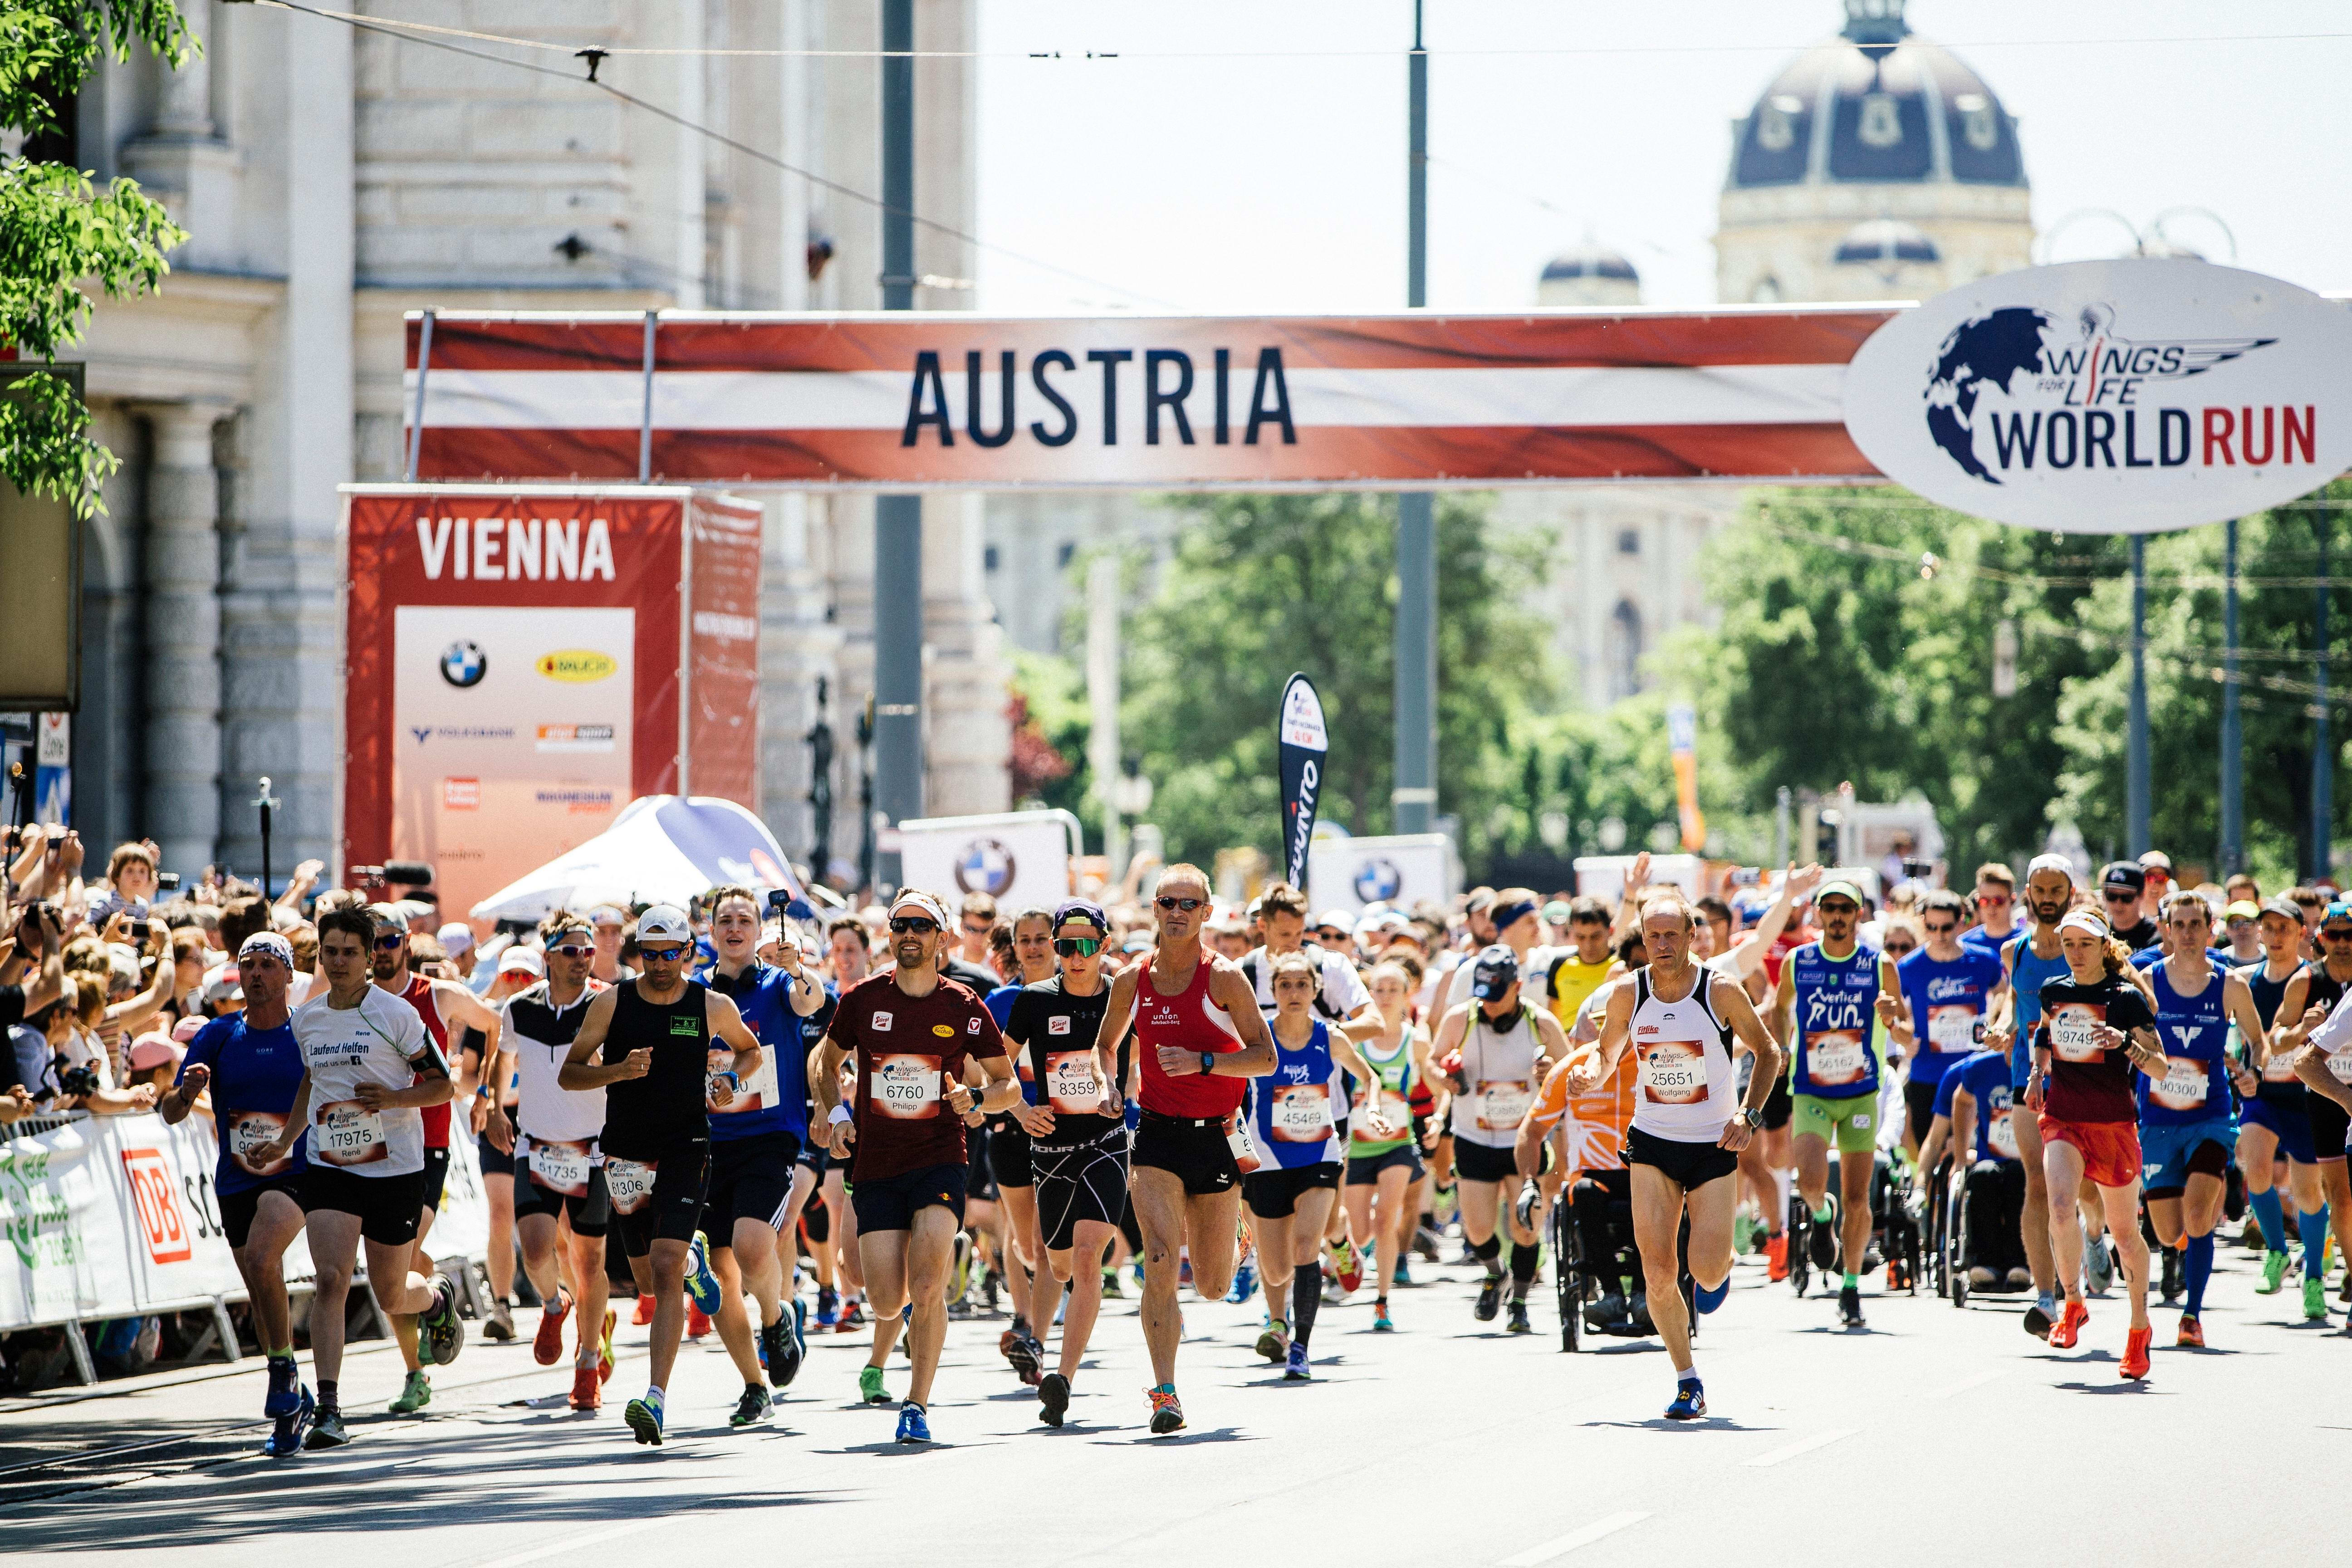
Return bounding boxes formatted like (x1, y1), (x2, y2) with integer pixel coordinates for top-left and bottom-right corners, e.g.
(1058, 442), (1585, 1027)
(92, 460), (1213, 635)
(0, 1117), (489, 1333)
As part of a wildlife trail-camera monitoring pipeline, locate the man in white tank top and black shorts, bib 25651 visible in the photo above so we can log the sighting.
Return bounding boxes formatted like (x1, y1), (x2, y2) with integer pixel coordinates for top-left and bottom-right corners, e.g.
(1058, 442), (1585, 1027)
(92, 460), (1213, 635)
(1567, 891), (1780, 1420)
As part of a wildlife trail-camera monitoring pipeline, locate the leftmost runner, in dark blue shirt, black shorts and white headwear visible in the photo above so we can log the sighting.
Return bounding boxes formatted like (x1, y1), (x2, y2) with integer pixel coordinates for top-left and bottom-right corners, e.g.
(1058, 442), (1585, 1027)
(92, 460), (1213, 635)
(155, 931), (310, 1453)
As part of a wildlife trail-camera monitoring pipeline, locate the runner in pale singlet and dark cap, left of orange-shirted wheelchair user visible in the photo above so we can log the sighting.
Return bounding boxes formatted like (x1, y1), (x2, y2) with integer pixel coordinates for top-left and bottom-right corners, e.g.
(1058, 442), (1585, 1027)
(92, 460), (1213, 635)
(1430, 945), (1569, 1333)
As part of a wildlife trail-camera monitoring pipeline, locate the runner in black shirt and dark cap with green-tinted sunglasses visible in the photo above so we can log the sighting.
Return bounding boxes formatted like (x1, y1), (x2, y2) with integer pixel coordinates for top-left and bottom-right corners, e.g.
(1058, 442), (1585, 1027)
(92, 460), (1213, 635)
(1004, 898), (1127, 1427)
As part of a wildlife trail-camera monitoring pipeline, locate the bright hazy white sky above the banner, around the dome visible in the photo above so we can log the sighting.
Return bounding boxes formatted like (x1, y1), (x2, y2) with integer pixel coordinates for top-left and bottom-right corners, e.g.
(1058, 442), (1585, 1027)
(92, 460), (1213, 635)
(979, 0), (2352, 313)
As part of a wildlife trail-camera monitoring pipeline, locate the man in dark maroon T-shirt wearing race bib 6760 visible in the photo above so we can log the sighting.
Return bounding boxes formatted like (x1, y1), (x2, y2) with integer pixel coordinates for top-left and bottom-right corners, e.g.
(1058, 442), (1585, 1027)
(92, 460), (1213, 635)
(814, 889), (1021, 1443)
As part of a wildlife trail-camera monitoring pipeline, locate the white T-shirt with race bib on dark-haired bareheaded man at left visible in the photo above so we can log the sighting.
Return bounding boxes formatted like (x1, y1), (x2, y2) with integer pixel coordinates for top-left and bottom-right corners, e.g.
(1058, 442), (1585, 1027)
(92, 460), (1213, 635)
(292, 985), (447, 1176)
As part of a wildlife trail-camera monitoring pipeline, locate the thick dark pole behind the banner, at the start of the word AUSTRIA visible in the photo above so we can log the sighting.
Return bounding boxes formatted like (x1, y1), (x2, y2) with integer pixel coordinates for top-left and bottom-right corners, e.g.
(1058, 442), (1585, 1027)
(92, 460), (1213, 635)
(872, 0), (922, 886)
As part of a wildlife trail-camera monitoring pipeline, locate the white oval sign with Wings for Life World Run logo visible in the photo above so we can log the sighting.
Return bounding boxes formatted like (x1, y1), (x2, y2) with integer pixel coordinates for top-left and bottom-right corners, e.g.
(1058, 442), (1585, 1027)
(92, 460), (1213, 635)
(1846, 259), (2352, 534)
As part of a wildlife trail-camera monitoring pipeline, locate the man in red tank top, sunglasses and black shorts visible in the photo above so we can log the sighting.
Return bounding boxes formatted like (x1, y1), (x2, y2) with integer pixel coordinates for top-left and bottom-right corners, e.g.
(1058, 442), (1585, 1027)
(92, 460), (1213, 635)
(1096, 865), (1275, 1431)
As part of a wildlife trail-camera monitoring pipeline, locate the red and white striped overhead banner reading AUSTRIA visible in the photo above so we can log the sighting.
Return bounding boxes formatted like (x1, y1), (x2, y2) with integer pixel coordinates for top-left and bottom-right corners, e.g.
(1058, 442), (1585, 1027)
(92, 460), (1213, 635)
(402, 308), (1891, 489)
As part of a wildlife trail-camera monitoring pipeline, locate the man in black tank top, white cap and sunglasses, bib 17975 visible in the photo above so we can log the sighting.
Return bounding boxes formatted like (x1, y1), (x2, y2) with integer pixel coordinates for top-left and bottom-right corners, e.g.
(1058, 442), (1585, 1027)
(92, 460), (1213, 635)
(555, 903), (767, 1446)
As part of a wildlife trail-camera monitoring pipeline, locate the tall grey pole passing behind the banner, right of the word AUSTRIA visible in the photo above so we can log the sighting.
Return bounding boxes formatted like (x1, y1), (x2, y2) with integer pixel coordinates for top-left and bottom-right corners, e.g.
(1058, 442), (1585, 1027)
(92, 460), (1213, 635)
(1390, 0), (1437, 832)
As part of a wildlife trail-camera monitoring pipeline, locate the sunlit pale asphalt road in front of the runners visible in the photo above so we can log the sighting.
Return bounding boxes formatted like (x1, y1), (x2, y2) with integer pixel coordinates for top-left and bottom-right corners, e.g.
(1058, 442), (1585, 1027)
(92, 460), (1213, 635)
(0, 1246), (2352, 1568)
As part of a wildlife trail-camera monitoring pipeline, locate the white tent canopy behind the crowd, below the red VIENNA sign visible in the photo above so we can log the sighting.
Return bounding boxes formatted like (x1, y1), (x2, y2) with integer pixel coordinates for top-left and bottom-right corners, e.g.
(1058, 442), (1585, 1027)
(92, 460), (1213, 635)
(473, 794), (804, 919)
